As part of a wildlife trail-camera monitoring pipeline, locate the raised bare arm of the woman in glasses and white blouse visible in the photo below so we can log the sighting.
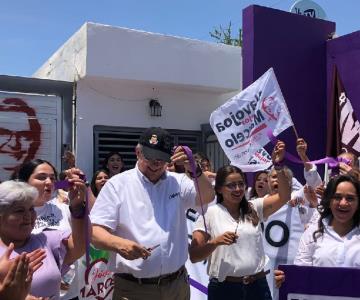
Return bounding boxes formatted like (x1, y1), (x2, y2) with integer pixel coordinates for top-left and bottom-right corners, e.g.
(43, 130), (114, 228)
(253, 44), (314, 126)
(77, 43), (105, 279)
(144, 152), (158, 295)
(263, 141), (291, 218)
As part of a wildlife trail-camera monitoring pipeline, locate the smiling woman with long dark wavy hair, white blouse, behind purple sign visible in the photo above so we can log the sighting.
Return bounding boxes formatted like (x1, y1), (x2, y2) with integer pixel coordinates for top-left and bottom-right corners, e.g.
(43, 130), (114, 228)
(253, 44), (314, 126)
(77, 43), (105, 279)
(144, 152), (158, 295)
(274, 175), (360, 287)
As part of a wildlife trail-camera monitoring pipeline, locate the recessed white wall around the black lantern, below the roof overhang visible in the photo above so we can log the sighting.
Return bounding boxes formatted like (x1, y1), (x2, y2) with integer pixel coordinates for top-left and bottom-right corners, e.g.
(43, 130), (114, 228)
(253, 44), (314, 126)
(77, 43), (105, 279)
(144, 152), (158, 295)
(76, 79), (236, 178)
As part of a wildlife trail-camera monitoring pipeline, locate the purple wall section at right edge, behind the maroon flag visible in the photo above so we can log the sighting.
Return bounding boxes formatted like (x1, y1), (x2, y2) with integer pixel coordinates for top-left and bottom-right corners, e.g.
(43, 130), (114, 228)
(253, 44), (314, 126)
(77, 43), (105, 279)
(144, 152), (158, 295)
(327, 31), (360, 115)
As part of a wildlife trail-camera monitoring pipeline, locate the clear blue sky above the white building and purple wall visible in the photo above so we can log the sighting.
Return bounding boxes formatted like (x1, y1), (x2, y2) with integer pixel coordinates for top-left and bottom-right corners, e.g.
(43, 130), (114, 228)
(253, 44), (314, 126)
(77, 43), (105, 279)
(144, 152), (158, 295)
(0, 0), (360, 76)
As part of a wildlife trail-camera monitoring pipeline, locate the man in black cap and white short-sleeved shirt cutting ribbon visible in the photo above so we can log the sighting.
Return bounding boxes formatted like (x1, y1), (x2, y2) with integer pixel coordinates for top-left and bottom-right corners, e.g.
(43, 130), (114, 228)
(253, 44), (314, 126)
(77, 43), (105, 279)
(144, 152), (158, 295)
(90, 127), (214, 300)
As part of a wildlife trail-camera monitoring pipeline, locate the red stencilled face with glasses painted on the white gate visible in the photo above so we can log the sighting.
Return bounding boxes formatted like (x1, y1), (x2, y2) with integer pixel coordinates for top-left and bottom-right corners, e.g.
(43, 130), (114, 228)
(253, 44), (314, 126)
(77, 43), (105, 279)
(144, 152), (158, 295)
(0, 98), (41, 180)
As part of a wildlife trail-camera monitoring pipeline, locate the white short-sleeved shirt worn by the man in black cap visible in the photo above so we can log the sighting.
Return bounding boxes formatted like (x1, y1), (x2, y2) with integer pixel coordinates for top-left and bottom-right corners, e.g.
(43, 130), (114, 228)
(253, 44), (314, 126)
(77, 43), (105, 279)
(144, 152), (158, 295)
(90, 166), (196, 278)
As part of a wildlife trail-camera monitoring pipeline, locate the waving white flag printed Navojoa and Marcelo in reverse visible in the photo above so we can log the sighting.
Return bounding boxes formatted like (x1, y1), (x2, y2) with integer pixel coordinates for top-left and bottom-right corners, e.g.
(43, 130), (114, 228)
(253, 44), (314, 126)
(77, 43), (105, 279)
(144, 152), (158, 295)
(210, 68), (293, 171)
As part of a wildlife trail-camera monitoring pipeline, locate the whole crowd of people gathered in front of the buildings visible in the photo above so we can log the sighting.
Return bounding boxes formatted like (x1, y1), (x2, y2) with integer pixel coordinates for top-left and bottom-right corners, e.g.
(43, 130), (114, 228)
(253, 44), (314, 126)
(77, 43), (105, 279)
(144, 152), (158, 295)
(0, 127), (360, 300)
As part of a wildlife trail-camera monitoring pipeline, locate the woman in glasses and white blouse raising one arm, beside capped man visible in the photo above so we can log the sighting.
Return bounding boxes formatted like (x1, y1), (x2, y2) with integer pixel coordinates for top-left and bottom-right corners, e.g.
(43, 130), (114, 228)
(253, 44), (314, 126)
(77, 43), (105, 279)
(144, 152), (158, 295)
(189, 142), (290, 300)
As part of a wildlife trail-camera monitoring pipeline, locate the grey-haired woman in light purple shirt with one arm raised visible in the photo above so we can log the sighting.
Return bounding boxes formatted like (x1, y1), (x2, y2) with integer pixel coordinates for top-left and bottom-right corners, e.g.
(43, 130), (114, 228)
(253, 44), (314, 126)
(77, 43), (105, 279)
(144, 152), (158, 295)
(0, 169), (86, 299)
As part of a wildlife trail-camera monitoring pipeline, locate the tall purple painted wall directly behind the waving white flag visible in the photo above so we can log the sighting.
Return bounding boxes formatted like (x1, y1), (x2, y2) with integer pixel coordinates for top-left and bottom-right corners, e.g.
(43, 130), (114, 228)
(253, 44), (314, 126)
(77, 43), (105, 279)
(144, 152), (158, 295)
(243, 5), (335, 181)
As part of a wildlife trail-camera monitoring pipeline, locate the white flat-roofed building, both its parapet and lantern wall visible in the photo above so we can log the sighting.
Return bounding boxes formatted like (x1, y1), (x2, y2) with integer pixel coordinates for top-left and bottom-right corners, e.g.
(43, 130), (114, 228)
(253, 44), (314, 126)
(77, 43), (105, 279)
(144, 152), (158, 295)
(34, 23), (242, 178)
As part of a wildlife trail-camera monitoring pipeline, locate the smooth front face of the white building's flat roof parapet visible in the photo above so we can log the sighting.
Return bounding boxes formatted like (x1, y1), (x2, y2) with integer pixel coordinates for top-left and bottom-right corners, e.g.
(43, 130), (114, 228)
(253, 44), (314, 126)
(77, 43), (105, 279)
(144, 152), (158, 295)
(86, 23), (242, 92)
